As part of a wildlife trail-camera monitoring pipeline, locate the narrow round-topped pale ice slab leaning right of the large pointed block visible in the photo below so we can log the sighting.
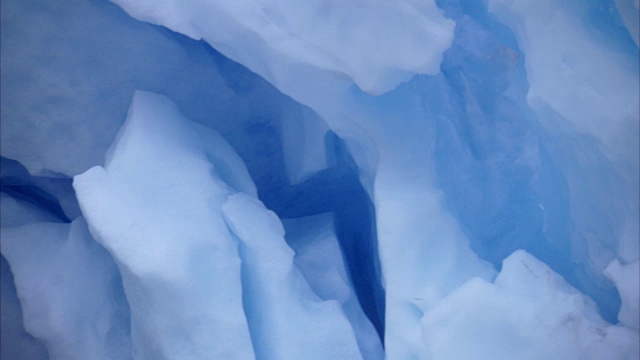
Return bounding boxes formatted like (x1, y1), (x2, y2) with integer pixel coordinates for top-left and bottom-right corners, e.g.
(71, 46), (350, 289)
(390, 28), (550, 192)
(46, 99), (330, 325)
(222, 193), (363, 360)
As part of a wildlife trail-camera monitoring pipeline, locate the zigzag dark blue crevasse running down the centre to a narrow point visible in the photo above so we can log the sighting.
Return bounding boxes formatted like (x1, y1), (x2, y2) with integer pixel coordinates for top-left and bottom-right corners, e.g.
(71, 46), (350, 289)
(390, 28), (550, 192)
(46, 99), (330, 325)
(192, 41), (385, 339)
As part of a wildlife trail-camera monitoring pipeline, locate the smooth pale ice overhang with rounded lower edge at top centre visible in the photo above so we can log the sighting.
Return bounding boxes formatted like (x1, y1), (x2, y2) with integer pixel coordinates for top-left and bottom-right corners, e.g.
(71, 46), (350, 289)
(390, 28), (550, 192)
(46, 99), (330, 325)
(114, 0), (454, 94)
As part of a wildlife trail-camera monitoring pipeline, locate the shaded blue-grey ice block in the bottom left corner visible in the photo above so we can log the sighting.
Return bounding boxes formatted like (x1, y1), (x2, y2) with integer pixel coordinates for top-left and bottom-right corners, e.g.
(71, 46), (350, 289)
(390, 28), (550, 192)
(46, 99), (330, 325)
(0, 218), (131, 360)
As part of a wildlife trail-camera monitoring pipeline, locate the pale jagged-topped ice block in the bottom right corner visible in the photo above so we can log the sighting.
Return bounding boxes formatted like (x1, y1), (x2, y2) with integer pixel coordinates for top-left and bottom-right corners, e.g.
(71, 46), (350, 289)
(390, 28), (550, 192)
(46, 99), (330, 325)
(422, 250), (640, 360)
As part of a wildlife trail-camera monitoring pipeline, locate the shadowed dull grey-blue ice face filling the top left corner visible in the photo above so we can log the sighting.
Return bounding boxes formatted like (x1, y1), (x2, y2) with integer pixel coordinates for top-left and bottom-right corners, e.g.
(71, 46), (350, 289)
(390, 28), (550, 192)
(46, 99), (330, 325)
(0, 0), (231, 177)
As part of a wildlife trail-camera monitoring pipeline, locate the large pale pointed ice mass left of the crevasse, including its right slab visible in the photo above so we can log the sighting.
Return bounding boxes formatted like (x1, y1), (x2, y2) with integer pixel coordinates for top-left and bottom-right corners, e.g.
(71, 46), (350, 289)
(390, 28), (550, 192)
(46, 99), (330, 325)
(74, 92), (361, 360)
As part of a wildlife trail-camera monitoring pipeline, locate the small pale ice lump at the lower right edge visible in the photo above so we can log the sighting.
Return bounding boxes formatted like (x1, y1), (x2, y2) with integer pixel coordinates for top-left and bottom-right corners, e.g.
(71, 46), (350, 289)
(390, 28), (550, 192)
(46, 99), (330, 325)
(604, 259), (640, 330)
